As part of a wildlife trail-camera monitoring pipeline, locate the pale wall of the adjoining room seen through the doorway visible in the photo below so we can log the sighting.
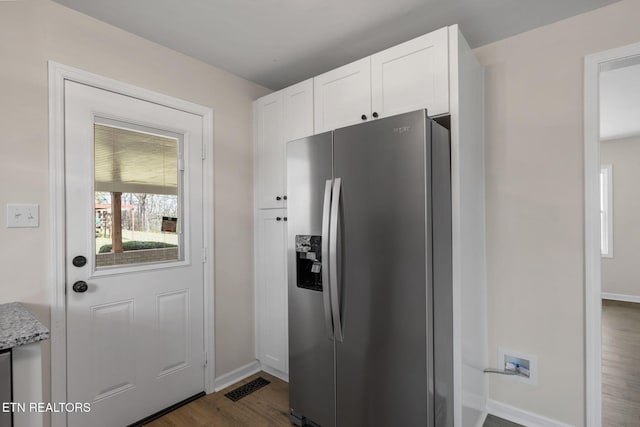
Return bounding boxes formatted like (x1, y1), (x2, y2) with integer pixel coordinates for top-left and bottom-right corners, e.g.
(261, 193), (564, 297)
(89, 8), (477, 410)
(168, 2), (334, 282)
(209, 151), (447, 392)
(600, 136), (640, 298)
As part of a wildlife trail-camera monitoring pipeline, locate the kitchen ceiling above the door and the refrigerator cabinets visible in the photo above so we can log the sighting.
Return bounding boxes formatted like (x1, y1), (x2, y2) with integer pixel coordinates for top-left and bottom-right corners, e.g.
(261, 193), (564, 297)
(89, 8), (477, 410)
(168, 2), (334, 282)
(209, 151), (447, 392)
(55, 0), (618, 90)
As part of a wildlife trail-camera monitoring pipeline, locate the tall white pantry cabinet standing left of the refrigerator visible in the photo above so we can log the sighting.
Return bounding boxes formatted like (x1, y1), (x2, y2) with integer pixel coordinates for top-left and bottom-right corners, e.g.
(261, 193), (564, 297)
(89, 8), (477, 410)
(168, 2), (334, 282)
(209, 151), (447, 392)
(254, 79), (313, 380)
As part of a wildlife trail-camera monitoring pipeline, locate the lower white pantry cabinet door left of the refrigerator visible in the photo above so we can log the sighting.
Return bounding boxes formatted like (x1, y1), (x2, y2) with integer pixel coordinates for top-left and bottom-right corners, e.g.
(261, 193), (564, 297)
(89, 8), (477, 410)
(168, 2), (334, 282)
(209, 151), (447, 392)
(256, 209), (289, 373)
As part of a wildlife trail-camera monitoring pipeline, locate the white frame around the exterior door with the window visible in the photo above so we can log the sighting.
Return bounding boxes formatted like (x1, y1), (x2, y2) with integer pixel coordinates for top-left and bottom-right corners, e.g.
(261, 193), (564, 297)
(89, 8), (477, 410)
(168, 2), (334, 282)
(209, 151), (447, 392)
(49, 61), (215, 427)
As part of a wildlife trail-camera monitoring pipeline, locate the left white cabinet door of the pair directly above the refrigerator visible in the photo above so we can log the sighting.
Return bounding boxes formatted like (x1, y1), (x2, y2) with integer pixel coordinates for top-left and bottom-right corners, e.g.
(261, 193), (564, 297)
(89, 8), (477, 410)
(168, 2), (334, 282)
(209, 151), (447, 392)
(313, 57), (371, 133)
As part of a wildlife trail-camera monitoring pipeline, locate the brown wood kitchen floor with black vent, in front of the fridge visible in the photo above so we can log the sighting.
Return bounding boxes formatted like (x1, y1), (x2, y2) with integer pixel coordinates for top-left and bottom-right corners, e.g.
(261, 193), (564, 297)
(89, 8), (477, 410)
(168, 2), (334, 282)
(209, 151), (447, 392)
(147, 372), (519, 427)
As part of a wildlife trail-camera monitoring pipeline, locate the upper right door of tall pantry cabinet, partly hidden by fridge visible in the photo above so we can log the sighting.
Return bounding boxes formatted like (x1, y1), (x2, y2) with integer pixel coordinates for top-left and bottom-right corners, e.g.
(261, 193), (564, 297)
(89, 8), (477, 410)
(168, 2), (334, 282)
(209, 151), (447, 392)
(282, 79), (313, 142)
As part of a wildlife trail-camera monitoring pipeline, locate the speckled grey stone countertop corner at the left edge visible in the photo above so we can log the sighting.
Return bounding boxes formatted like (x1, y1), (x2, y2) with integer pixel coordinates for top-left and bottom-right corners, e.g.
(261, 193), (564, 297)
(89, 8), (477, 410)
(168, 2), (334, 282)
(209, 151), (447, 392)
(0, 302), (49, 350)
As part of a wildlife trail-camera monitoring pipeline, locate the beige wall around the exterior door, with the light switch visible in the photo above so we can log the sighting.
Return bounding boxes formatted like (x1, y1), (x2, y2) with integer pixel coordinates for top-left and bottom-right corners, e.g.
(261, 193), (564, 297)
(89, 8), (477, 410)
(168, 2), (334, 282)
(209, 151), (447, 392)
(0, 0), (269, 414)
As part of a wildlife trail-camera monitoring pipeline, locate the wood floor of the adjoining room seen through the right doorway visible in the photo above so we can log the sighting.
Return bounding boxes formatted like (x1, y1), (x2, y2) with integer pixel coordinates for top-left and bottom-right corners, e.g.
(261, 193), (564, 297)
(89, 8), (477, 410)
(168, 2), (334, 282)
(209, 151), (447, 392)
(602, 300), (640, 427)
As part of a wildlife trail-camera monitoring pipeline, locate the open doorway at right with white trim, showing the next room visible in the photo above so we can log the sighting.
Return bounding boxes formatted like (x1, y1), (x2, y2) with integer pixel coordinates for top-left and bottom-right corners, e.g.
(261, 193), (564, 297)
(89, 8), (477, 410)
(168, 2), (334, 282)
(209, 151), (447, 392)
(584, 44), (640, 427)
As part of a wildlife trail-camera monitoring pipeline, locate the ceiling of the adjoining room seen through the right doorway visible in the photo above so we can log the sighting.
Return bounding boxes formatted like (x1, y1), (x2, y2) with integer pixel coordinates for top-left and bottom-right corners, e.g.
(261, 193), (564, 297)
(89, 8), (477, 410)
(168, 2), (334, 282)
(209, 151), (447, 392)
(600, 56), (640, 140)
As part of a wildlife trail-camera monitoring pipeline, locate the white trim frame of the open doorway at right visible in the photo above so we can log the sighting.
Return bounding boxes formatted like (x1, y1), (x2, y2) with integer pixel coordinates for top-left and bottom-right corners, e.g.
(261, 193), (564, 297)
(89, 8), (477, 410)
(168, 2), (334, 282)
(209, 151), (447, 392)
(584, 43), (640, 427)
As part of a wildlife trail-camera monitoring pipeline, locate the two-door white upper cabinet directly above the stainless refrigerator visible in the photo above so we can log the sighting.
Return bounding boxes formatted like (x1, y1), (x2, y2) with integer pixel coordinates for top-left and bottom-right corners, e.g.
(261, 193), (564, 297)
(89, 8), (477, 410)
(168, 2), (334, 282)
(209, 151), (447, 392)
(314, 28), (449, 133)
